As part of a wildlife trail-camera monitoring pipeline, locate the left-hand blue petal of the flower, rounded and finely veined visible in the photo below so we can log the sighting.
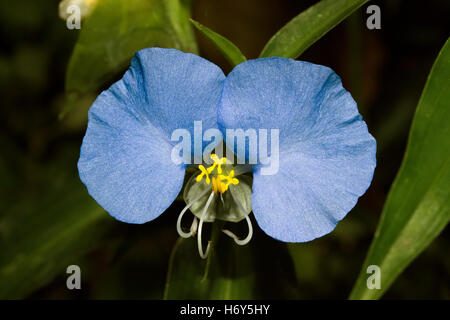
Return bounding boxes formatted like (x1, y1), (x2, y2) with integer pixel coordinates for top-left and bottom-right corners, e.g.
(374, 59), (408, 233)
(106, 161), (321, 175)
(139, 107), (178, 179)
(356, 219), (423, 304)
(78, 48), (225, 223)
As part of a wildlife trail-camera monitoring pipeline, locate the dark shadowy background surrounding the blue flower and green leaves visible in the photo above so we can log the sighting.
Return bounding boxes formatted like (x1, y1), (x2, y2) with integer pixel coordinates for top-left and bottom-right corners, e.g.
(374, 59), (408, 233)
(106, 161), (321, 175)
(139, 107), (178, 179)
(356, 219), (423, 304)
(0, 0), (450, 299)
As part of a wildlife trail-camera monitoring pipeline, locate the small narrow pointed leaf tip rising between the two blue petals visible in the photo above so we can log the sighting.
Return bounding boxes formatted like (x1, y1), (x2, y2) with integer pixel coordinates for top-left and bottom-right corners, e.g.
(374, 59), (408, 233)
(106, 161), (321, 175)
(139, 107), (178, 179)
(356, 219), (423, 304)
(190, 19), (247, 67)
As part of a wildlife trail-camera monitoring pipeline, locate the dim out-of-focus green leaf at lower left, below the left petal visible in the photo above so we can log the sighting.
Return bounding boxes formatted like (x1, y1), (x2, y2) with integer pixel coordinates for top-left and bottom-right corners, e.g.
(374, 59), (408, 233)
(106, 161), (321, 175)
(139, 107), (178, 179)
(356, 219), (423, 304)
(0, 149), (112, 299)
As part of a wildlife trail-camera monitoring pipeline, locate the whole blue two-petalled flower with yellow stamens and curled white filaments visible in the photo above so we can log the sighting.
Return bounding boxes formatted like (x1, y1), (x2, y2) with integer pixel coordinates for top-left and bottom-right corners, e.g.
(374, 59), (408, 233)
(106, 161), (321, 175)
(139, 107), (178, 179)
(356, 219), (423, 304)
(78, 48), (376, 257)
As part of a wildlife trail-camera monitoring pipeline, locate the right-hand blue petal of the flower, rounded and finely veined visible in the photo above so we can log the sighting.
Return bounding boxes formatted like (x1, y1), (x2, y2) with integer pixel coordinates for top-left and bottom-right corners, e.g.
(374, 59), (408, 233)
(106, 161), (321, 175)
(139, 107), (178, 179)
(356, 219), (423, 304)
(218, 58), (376, 242)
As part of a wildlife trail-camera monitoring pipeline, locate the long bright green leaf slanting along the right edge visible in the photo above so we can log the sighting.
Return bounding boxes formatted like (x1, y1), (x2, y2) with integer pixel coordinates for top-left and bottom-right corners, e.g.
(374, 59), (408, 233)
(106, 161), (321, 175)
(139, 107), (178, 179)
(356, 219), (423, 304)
(350, 40), (450, 299)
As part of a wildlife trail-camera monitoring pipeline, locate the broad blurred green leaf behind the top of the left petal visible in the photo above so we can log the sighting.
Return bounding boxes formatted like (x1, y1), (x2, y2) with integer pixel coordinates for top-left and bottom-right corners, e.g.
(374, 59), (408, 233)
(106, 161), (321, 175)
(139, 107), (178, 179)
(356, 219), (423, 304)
(66, 0), (197, 94)
